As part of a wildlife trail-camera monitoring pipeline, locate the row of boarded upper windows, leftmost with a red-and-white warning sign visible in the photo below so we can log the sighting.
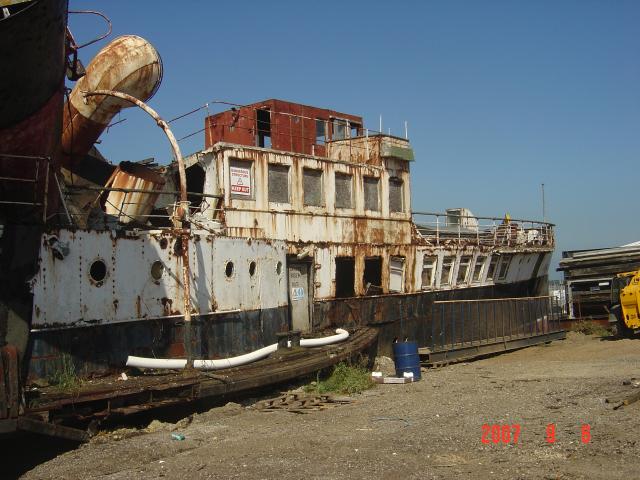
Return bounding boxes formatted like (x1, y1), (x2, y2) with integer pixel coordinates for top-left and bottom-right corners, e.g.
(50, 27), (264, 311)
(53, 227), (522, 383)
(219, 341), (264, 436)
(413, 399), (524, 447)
(230, 161), (405, 213)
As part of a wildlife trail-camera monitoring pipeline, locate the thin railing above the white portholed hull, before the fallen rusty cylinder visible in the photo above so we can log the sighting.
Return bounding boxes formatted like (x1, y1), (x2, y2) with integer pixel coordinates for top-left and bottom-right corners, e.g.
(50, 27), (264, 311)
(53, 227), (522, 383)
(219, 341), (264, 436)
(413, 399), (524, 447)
(62, 185), (223, 230)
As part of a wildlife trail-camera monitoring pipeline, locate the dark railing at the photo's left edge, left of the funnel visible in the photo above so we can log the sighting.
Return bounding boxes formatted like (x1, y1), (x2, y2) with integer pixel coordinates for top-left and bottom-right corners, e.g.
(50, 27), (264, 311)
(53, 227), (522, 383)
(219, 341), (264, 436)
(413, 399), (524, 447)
(0, 153), (54, 222)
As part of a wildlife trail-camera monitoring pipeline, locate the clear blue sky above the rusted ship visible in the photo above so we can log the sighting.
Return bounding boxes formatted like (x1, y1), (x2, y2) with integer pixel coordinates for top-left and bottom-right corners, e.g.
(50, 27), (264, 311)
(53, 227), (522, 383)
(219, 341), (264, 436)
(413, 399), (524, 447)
(70, 0), (640, 275)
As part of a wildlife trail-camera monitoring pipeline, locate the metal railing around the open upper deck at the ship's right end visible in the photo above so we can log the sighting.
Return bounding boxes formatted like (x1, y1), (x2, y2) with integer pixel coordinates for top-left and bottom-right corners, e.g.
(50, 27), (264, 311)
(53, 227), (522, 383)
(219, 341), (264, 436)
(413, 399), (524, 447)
(412, 212), (555, 247)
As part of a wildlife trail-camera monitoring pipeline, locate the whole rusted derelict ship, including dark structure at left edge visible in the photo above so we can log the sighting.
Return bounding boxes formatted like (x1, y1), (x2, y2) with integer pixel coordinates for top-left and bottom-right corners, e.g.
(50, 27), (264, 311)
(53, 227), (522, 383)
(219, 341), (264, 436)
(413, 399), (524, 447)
(0, 0), (560, 436)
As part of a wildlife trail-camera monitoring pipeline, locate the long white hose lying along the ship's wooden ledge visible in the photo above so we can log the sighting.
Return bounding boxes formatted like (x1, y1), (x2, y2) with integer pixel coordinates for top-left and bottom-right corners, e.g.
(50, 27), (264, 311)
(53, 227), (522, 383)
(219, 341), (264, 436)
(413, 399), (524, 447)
(127, 328), (349, 370)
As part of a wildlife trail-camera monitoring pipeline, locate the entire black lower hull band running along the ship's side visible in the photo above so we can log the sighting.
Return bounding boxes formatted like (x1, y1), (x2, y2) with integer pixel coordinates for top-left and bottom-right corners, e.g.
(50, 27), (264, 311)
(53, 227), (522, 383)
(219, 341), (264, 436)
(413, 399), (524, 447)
(27, 277), (546, 380)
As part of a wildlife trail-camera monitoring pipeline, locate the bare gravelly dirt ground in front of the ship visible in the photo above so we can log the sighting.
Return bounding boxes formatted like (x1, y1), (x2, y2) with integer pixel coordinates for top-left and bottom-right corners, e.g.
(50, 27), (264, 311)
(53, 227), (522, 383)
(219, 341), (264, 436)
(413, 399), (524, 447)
(11, 333), (640, 480)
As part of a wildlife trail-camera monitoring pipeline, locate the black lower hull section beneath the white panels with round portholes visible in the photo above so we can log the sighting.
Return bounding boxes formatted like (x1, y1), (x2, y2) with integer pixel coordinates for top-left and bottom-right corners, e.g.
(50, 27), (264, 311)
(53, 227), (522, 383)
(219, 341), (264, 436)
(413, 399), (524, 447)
(28, 306), (289, 380)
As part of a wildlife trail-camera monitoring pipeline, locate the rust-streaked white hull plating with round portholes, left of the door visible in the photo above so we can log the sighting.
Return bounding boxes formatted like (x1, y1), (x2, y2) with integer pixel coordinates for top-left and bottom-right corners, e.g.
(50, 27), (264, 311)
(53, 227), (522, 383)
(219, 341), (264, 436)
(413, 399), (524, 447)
(32, 230), (287, 328)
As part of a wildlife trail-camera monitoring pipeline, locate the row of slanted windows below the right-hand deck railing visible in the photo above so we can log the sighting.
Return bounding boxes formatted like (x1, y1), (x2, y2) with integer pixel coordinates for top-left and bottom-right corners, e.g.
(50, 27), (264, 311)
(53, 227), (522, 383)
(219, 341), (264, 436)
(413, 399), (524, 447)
(422, 255), (512, 289)
